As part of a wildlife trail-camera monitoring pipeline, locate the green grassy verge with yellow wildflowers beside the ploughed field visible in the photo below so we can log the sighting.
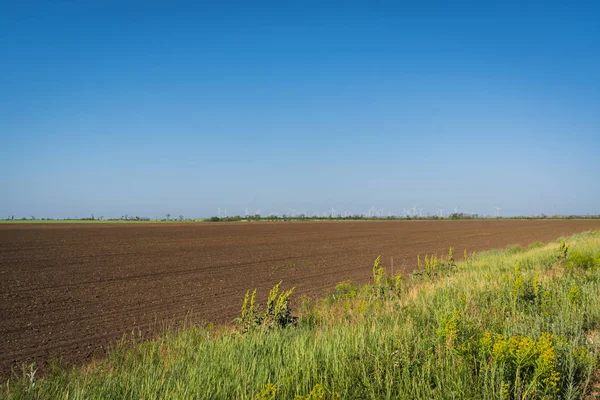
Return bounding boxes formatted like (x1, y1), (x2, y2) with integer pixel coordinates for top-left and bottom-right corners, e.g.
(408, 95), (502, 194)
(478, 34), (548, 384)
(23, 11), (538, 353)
(0, 231), (600, 399)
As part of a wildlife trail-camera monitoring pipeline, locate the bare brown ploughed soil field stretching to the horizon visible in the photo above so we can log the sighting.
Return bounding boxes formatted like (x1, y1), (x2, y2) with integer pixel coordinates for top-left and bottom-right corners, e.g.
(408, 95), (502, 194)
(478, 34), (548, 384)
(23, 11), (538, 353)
(0, 220), (600, 379)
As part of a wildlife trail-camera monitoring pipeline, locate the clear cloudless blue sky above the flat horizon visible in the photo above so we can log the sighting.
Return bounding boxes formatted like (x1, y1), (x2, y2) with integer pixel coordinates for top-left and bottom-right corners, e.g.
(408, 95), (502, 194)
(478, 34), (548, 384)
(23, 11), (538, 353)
(0, 1), (600, 218)
